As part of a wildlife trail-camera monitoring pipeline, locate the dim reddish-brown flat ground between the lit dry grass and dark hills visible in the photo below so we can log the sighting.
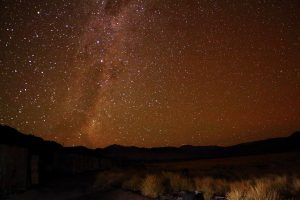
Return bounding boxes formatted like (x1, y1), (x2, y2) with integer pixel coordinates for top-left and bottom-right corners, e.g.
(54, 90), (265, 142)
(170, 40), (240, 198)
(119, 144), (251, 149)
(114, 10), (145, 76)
(146, 152), (300, 178)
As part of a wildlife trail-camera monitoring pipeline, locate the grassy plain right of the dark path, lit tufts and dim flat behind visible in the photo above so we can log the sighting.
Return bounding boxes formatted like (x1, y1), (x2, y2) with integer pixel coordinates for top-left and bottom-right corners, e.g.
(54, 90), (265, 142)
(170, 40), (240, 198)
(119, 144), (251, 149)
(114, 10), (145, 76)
(94, 152), (300, 200)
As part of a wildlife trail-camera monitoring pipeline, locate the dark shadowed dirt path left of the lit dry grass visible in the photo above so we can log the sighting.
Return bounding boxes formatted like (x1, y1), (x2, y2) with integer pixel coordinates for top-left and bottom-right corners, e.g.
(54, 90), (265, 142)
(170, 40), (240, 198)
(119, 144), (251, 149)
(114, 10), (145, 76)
(8, 173), (150, 200)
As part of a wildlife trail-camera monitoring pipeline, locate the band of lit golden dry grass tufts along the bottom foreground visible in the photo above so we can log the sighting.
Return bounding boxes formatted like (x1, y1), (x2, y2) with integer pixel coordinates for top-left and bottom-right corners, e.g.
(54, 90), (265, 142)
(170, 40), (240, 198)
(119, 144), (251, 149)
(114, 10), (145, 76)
(95, 171), (300, 200)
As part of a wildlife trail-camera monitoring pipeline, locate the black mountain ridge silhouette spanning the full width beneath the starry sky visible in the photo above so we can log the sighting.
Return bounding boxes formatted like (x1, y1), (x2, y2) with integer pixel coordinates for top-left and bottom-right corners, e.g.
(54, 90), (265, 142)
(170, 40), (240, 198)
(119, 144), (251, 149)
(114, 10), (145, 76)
(0, 126), (300, 161)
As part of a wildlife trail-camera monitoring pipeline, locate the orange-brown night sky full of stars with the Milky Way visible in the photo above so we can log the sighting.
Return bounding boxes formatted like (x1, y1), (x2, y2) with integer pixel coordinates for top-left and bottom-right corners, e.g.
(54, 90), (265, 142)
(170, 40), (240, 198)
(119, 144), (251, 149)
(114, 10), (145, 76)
(0, 0), (300, 148)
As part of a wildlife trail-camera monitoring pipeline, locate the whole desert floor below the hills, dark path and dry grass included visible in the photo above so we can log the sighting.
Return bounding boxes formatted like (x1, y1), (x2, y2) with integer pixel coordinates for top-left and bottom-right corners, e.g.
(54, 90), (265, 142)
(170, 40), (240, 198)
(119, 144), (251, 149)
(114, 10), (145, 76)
(9, 152), (300, 200)
